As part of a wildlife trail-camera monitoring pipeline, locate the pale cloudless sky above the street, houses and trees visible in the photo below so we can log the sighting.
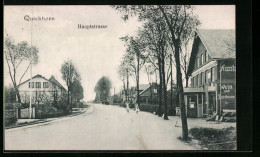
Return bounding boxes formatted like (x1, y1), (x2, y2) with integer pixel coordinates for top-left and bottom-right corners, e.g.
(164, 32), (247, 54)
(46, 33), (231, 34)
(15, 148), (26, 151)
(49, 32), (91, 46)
(4, 5), (235, 100)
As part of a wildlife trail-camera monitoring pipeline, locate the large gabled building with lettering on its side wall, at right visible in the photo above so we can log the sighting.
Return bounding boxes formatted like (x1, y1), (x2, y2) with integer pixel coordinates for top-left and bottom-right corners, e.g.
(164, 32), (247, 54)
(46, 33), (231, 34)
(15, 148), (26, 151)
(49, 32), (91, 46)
(184, 30), (236, 117)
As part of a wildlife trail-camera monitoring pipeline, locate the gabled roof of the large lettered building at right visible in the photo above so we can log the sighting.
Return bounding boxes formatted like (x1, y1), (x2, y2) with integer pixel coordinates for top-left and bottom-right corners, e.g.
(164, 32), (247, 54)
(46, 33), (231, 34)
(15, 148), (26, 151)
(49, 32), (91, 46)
(188, 29), (236, 75)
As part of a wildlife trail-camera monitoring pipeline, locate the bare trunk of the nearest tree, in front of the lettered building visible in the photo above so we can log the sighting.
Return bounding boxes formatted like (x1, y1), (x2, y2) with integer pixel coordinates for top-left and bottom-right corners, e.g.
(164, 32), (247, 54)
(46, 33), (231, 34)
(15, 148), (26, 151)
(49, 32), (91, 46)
(174, 43), (188, 141)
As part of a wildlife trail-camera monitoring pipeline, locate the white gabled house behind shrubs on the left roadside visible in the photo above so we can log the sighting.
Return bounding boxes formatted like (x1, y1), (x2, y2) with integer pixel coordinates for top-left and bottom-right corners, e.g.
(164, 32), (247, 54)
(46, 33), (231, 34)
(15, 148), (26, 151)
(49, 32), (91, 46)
(18, 74), (67, 104)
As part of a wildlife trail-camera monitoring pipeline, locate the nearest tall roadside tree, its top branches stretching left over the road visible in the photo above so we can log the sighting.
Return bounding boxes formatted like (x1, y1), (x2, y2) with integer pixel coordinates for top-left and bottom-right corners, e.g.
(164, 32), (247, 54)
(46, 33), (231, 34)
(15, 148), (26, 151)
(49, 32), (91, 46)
(112, 5), (200, 141)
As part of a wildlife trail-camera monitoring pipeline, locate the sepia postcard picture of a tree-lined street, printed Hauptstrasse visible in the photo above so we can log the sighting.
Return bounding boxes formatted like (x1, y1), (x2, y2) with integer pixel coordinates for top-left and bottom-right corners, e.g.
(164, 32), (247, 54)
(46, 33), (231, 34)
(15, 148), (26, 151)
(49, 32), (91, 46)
(3, 5), (237, 151)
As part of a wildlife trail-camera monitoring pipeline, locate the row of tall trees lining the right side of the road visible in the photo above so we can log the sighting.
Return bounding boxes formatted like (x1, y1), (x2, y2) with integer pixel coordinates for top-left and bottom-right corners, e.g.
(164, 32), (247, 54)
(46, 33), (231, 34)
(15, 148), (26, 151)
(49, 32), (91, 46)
(112, 5), (200, 140)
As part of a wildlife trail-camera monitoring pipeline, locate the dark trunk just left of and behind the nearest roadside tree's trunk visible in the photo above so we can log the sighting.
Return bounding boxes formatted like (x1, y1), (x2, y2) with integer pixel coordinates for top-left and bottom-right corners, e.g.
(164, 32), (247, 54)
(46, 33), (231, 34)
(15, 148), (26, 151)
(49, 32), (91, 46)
(162, 52), (169, 120)
